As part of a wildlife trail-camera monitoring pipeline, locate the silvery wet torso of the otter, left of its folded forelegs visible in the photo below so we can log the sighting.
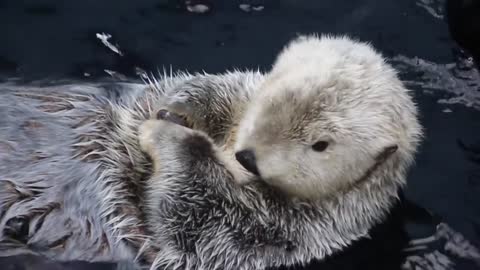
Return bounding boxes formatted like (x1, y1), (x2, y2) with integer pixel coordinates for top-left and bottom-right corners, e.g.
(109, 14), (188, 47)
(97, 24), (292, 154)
(0, 72), (262, 268)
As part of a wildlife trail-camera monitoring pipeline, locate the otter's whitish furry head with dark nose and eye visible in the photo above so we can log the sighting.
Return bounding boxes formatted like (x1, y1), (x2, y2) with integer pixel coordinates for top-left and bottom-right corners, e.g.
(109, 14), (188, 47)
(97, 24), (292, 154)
(235, 36), (422, 198)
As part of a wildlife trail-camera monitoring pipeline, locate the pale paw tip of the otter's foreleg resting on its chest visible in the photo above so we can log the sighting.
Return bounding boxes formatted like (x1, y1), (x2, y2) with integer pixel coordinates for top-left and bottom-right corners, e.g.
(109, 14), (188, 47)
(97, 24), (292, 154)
(138, 120), (193, 154)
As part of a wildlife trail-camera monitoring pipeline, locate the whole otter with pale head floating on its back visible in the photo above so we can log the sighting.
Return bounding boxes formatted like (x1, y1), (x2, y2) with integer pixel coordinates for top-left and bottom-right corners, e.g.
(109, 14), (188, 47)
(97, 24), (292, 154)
(0, 36), (421, 269)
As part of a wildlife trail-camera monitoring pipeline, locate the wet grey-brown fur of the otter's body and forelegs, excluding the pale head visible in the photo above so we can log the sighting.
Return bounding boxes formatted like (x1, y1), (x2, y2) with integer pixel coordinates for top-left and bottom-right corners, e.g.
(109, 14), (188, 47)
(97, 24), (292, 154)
(0, 34), (420, 270)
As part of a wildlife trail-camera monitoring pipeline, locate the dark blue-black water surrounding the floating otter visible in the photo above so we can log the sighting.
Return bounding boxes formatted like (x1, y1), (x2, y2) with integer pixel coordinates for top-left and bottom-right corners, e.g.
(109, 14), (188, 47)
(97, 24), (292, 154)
(0, 0), (480, 269)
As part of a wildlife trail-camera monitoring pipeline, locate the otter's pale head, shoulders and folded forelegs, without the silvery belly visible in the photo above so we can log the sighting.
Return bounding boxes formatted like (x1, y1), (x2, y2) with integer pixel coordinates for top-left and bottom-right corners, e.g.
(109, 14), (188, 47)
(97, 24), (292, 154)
(134, 36), (422, 269)
